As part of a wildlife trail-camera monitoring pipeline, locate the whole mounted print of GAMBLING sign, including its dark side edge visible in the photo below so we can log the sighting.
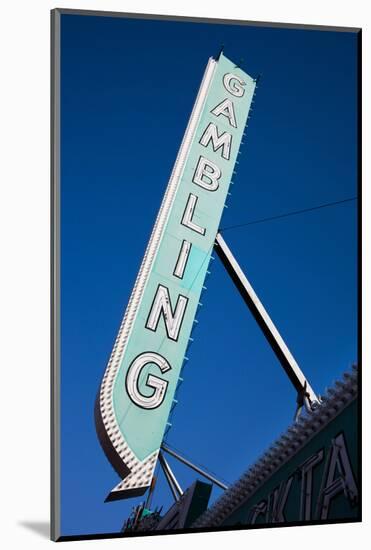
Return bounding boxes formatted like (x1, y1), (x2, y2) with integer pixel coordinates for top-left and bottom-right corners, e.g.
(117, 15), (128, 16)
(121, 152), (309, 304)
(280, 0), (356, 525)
(51, 9), (361, 541)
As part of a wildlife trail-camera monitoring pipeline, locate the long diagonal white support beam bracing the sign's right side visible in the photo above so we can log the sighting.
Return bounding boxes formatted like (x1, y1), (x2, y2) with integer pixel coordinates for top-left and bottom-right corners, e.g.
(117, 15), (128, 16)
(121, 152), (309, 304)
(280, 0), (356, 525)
(215, 233), (319, 409)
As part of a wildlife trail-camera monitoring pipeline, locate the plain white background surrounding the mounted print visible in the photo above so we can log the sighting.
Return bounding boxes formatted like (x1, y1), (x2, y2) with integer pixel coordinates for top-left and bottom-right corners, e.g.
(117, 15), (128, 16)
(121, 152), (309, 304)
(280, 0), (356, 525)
(0, 0), (371, 550)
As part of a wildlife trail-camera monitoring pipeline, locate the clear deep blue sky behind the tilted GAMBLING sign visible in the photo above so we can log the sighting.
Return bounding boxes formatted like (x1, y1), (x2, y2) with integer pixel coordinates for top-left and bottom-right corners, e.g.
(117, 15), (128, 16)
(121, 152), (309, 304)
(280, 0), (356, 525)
(61, 15), (357, 535)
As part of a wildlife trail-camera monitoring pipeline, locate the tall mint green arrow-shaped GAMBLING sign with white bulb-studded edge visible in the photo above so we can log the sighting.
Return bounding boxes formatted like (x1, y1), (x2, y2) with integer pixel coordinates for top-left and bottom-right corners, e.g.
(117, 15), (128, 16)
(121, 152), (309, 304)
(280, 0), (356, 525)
(95, 55), (255, 500)
